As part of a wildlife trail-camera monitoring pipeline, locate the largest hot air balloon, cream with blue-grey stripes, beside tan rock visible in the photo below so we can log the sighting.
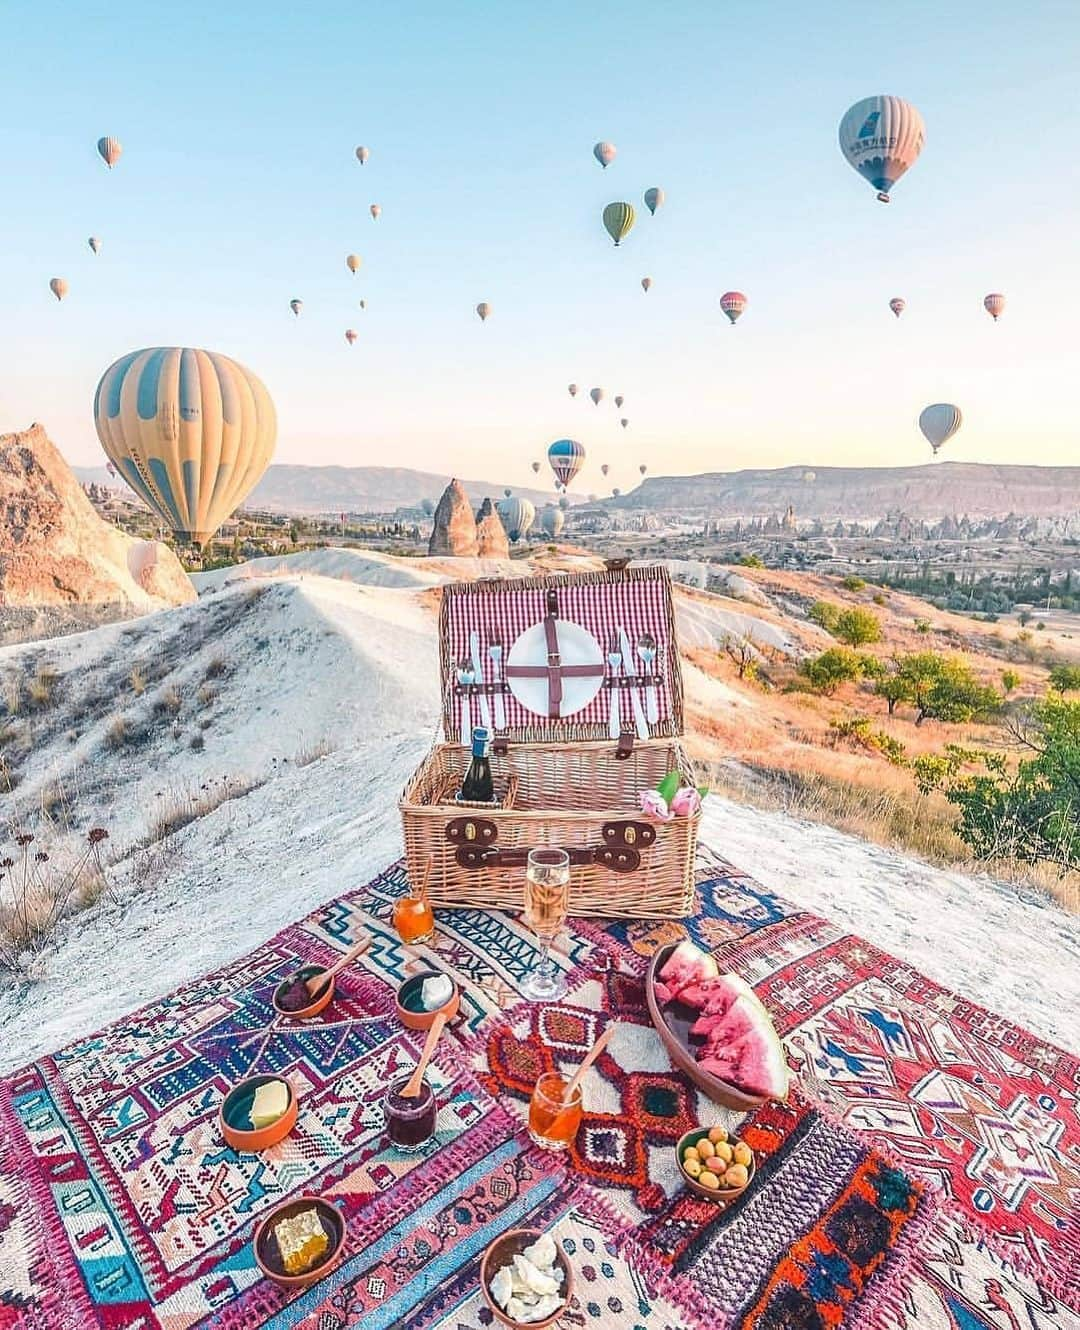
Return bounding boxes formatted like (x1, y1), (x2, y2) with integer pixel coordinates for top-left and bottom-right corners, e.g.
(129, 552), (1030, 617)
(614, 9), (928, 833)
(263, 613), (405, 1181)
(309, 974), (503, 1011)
(93, 346), (278, 545)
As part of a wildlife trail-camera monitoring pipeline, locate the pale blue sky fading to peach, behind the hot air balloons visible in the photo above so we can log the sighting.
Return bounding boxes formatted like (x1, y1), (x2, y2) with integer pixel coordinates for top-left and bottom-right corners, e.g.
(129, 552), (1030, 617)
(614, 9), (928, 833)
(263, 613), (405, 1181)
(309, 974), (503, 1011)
(0, 0), (1080, 489)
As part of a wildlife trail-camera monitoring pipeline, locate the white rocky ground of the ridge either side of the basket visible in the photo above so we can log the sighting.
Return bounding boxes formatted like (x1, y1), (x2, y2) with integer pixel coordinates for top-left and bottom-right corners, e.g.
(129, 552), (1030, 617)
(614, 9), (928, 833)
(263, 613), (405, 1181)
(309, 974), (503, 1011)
(0, 551), (1080, 1072)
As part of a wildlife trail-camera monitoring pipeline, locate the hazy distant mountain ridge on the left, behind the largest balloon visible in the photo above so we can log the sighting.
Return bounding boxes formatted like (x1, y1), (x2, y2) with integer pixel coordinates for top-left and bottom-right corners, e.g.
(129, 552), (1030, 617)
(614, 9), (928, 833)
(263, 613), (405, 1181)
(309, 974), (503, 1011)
(74, 463), (555, 513)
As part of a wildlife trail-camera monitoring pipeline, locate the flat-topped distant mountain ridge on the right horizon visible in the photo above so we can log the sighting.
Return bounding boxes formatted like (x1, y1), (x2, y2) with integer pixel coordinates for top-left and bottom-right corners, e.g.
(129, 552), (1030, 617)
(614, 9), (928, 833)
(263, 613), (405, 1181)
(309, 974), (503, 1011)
(605, 462), (1080, 521)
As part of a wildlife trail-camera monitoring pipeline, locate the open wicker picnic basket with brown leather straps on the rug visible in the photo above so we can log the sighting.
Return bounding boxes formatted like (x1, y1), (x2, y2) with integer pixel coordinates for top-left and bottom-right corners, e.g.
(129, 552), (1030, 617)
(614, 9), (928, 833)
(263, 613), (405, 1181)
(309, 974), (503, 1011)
(400, 567), (700, 919)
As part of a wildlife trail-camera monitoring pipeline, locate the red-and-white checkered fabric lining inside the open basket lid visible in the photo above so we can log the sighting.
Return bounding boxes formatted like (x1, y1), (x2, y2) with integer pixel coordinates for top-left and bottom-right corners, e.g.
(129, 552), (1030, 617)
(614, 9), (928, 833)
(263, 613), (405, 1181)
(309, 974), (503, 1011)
(444, 577), (673, 741)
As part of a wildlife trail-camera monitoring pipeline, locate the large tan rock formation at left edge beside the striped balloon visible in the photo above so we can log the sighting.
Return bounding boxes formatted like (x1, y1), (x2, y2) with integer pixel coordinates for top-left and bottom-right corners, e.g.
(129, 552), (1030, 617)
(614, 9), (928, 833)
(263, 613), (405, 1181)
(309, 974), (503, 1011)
(0, 424), (196, 613)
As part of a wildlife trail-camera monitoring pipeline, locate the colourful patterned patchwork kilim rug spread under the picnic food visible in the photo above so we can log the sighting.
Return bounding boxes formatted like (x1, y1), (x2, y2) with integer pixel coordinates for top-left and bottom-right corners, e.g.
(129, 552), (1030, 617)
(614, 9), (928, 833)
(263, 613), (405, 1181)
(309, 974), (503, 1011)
(0, 857), (1080, 1330)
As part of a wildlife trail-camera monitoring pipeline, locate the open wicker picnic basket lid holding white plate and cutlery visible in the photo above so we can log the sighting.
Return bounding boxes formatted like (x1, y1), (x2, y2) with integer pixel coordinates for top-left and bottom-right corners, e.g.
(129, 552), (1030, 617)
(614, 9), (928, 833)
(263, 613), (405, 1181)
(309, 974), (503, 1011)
(439, 564), (684, 743)
